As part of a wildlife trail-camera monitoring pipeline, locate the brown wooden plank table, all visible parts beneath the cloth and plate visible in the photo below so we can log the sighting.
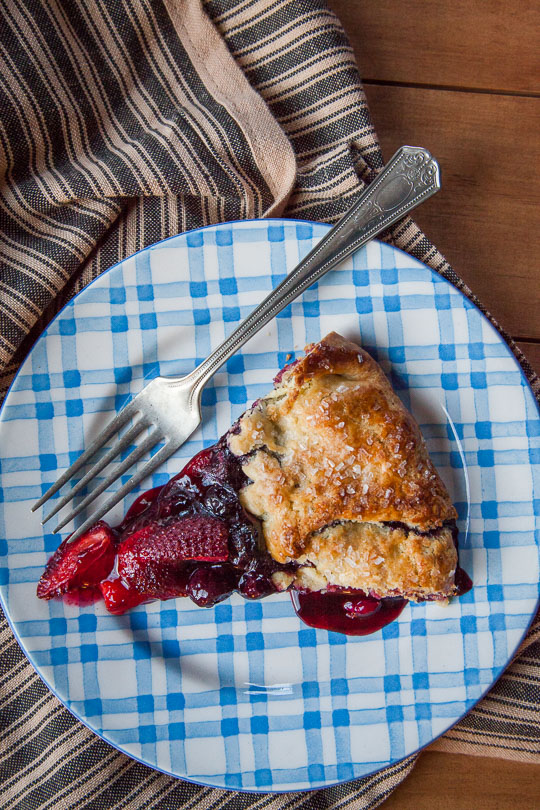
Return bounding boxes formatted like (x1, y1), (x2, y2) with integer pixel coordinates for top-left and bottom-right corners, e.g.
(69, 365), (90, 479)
(329, 0), (540, 810)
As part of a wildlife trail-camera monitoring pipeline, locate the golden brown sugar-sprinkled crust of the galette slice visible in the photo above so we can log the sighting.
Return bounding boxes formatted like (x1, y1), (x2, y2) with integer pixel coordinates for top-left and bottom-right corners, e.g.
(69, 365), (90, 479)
(229, 333), (457, 595)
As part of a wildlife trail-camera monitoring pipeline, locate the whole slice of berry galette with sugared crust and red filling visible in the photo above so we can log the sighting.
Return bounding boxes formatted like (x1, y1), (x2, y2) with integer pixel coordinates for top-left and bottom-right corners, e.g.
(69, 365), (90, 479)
(38, 333), (471, 635)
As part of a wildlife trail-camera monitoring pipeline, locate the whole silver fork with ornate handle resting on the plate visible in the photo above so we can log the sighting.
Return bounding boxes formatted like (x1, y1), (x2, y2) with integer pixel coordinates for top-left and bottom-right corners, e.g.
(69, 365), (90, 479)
(32, 146), (440, 541)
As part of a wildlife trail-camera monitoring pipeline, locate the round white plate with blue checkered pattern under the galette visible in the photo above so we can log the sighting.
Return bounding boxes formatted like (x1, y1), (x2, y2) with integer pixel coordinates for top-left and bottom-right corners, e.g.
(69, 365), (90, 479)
(0, 220), (540, 791)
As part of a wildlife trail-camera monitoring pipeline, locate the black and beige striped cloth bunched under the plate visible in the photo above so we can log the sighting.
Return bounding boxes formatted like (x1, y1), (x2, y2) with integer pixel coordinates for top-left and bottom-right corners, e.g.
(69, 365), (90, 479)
(0, 0), (540, 810)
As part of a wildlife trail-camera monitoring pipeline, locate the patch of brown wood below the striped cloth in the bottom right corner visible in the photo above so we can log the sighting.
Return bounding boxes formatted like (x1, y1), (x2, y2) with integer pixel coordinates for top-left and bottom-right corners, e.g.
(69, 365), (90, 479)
(379, 750), (540, 810)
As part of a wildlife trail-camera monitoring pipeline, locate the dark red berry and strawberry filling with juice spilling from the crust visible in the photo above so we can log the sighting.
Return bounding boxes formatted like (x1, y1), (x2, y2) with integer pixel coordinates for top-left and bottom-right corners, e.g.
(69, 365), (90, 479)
(37, 437), (470, 635)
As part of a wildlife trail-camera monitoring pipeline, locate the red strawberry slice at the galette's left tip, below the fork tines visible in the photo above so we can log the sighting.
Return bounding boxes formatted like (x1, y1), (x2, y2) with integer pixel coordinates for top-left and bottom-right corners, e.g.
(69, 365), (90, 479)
(37, 521), (116, 599)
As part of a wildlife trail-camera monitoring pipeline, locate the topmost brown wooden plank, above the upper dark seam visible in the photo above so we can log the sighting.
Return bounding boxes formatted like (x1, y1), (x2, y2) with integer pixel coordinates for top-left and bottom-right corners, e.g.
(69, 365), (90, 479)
(330, 0), (540, 93)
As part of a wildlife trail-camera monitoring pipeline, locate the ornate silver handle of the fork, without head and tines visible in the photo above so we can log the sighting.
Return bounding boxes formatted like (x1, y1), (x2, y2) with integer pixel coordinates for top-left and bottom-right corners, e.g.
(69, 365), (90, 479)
(180, 146), (440, 393)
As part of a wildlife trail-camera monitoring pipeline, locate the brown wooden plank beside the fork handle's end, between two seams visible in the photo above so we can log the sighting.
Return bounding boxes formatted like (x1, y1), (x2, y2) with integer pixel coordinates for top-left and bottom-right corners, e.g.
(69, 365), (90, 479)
(365, 83), (540, 339)
